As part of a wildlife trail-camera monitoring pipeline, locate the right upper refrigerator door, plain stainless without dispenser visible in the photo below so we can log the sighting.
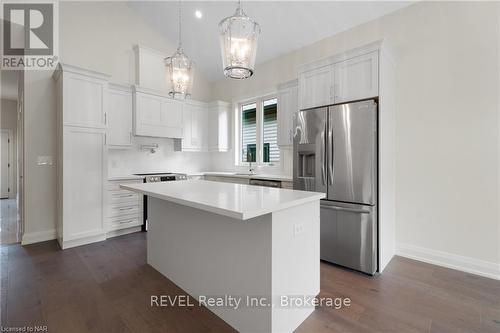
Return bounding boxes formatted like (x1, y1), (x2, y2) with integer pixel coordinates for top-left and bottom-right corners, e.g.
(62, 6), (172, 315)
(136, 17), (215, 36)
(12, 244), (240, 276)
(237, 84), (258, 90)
(327, 100), (377, 205)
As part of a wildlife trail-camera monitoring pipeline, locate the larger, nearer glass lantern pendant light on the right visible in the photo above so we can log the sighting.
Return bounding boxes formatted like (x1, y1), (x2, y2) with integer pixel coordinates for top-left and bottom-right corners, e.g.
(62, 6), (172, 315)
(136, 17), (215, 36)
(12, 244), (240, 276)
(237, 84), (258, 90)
(219, 1), (260, 79)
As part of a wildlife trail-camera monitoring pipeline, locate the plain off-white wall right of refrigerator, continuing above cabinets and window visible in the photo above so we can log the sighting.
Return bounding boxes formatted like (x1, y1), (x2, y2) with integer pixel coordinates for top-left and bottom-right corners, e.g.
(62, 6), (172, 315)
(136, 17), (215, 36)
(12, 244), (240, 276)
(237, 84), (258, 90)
(213, 2), (500, 270)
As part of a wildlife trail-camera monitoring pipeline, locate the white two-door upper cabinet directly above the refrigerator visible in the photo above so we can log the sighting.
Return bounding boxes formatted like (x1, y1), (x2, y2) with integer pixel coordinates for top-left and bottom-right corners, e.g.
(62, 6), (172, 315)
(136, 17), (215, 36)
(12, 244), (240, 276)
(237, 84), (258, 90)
(299, 49), (379, 110)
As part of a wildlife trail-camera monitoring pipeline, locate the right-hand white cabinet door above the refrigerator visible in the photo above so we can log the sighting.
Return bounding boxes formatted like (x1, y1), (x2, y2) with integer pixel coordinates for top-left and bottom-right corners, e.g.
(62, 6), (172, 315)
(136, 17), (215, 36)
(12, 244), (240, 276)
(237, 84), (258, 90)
(334, 51), (378, 103)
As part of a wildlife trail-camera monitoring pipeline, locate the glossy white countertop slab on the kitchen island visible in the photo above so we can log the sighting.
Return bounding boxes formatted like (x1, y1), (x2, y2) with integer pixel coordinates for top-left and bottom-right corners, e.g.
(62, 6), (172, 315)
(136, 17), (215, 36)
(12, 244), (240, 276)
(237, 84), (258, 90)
(120, 180), (325, 220)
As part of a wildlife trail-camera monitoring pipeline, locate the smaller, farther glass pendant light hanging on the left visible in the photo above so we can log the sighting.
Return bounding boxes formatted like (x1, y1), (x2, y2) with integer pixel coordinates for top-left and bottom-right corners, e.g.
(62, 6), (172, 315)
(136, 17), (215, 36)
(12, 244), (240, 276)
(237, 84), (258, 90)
(165, 0), (194, 98)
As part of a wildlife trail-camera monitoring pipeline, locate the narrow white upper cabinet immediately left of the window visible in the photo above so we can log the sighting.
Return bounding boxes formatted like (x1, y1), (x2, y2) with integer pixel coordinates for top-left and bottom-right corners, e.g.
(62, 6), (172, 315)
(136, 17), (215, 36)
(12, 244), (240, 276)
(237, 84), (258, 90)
(208, 101), (231, 152)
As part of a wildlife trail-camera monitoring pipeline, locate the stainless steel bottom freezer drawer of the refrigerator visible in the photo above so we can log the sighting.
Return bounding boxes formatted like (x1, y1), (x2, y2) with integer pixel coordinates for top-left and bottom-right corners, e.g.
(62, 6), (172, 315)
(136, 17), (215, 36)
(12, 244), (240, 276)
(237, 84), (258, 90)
(320, 201), (377, 274)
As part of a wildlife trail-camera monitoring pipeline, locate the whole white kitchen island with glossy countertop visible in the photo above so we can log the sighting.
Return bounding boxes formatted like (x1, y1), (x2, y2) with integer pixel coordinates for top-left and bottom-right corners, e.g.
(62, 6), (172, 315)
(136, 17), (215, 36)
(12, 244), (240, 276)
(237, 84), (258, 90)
(121, 180), (324, 332)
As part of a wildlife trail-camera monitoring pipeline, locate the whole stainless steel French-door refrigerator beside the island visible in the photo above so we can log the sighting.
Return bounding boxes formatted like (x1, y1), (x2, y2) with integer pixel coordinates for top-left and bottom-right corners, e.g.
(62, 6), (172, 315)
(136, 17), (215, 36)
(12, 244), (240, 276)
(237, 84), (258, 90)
(293, 100), (378, 274)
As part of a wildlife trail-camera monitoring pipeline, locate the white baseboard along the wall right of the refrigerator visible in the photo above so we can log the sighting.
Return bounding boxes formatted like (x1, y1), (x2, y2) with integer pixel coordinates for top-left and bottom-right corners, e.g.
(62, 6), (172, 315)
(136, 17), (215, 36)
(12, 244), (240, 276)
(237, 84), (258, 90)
(396, 243), (500, 280)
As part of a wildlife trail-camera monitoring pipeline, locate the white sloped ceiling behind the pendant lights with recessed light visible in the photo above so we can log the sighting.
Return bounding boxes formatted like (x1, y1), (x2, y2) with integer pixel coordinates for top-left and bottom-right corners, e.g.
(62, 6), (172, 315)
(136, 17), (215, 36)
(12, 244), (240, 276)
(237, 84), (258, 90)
(129, 1), (412, 81)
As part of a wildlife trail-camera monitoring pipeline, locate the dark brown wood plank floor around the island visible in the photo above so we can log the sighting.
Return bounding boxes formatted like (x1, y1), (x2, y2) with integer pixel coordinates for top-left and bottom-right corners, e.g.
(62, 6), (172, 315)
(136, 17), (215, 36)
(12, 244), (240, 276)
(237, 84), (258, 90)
(0, 233), (500, 333)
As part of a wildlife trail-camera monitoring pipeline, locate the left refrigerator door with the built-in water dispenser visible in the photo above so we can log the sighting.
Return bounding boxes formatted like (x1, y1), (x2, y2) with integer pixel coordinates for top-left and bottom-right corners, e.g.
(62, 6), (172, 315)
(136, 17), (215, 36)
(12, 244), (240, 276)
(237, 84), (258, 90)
(293, 108), (328, 193)
